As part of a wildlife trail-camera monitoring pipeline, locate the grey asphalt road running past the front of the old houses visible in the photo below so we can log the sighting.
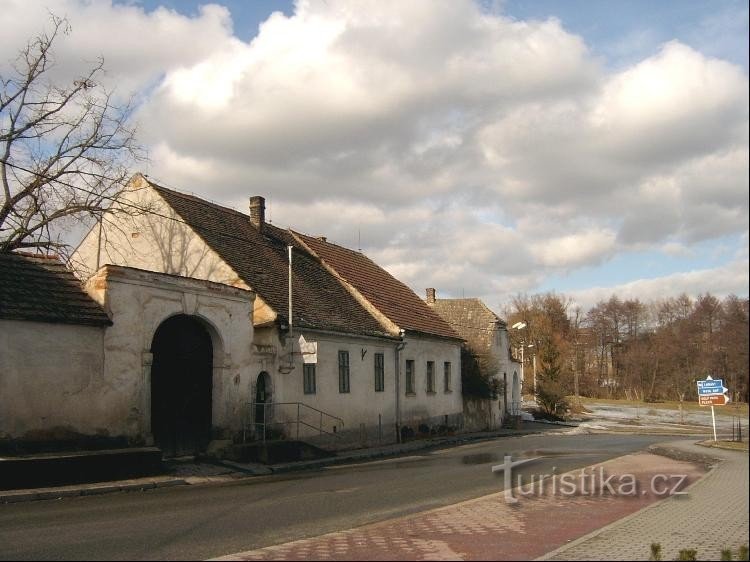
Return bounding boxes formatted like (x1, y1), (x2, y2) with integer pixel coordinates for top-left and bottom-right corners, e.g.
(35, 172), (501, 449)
(0, 434), (692, 560)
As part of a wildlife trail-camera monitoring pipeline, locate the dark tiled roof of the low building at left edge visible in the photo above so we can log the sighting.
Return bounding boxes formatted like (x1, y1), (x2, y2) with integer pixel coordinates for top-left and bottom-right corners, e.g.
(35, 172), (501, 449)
(0, 254), (112, 326)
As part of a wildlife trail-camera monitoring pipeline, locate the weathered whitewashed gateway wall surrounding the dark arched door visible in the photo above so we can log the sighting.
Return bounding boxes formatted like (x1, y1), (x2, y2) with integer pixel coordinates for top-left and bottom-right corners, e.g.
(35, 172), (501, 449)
(87, 266), (254, 442)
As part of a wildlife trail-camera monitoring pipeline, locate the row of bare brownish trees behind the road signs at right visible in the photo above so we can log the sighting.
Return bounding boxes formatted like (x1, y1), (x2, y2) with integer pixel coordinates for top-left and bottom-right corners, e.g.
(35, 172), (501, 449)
(505, 293), (748, 402)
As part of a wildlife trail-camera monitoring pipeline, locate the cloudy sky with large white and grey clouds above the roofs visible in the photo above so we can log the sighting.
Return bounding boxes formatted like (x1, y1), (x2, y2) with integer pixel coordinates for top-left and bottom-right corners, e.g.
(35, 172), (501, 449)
(0, 0), (748, 310)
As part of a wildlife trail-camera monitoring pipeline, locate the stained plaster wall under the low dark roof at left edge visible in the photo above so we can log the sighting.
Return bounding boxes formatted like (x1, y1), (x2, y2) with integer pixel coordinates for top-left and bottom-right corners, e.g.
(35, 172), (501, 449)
(0, 320), (107, 441)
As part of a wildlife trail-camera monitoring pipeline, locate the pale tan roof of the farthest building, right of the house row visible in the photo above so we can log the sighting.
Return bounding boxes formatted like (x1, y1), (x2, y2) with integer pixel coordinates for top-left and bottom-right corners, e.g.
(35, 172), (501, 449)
(429, 298), (505, 350)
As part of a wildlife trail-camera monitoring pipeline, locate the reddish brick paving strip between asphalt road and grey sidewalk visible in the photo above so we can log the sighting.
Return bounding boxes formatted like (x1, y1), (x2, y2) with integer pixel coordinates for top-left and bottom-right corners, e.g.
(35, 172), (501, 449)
(214, 453), (704, 560)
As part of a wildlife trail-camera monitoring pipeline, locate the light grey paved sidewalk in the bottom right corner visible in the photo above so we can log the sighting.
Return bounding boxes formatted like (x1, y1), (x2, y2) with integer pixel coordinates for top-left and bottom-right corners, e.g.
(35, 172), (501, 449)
(539, 441), (750, 560)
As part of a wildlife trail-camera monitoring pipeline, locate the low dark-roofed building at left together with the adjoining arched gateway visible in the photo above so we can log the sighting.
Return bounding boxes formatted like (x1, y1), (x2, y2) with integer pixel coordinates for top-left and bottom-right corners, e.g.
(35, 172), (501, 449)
(0, 250), (254, 455)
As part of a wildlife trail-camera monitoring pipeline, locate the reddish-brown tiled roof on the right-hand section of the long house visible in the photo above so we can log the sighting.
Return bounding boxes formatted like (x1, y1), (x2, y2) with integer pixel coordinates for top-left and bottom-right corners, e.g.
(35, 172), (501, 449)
(297, 234), (462, 339)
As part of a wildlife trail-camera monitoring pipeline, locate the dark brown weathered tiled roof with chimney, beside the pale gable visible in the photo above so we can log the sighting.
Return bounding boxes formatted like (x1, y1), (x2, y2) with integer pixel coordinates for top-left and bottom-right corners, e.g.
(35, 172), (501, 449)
(151, 183), (388, 336)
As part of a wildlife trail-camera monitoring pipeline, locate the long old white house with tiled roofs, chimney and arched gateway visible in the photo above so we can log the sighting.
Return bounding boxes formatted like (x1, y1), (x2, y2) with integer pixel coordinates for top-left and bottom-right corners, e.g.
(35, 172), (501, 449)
(64, 175), (462, 454)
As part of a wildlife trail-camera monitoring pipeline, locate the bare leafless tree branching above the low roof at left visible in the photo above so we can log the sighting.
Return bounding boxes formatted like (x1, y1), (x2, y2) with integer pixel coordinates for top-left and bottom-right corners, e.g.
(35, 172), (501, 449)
(0, 15), (143, 252)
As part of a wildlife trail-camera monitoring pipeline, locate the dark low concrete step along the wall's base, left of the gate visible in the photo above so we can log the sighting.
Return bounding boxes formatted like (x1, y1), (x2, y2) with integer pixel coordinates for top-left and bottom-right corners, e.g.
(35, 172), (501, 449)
(0, 447), (164, 490)
